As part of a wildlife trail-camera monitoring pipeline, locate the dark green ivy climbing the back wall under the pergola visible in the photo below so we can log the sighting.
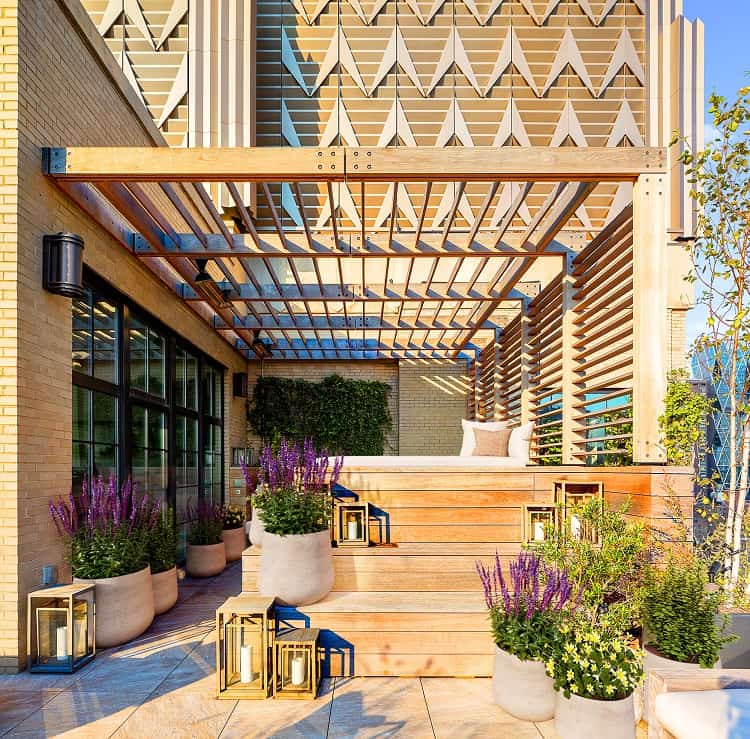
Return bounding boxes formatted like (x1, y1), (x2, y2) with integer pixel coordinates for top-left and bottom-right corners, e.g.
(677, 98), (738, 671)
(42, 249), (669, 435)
(248, 375), (392, 456)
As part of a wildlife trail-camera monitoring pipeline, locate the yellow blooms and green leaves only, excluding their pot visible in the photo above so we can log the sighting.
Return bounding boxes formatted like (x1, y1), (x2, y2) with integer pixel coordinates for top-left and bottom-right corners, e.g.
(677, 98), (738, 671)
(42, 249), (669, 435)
(547, 620), (643, 701)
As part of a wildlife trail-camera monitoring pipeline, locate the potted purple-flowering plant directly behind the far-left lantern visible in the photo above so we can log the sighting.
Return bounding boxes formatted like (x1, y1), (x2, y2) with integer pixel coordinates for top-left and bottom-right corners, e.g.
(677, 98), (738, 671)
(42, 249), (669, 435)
(49, 477), (160, 648)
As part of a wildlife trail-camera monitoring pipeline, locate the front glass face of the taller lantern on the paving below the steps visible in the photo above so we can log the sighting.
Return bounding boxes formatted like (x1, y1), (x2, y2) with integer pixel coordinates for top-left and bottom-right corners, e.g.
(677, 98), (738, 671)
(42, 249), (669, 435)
(224, 616), (266, 689)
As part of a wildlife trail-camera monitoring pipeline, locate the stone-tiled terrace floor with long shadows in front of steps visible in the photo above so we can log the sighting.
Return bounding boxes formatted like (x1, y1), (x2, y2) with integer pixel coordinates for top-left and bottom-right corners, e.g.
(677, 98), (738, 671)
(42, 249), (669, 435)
(0, 563), (568, 739)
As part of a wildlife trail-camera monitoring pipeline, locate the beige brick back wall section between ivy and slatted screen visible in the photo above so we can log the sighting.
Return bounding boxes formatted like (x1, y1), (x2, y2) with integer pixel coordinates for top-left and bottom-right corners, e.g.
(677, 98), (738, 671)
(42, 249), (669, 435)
(398, 360), (471, 455)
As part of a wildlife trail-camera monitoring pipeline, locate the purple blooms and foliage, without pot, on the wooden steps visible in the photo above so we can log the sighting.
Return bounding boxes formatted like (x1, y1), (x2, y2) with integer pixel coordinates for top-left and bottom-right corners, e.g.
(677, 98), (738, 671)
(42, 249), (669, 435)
(252, 439), (343, 536)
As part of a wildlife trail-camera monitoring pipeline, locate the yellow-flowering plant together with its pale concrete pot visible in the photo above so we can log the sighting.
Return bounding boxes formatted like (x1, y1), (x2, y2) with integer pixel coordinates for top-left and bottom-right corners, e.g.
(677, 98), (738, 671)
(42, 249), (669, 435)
(547, 619), (643, 739)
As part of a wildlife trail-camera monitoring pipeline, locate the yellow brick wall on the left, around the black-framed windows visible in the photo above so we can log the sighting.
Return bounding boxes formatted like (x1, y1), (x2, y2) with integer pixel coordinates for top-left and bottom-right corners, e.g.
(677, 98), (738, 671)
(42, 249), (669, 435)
(0, 0), (246, 671)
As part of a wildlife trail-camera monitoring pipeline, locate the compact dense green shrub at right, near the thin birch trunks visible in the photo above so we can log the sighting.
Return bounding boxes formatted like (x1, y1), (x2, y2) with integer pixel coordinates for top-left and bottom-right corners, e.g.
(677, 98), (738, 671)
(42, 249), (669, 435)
(643, 559), (734, 667)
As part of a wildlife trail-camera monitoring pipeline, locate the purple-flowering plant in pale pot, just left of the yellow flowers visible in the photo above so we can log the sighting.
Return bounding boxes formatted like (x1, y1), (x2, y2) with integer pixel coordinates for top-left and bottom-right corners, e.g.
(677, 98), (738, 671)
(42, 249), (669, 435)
(476, 552), (576, 721)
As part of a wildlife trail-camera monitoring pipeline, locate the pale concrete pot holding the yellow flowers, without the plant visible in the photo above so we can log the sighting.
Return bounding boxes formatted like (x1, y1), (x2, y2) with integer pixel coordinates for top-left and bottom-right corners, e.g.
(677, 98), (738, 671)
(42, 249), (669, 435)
(555, 693), (635, 739)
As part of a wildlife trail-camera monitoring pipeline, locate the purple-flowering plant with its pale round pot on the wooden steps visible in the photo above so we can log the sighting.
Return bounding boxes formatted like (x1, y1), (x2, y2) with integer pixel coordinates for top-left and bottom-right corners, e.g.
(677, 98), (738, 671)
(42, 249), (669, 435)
(253, 440), (342, 606)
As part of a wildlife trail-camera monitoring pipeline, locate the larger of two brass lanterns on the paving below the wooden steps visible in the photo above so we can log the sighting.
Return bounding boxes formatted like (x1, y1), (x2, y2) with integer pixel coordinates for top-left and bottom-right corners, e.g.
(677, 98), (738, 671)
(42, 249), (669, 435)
(216, 595), (275, 700)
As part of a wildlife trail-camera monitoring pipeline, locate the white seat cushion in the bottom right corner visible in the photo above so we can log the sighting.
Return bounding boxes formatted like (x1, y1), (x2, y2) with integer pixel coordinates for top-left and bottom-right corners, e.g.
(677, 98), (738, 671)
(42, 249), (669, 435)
(654, 689), (750, 739)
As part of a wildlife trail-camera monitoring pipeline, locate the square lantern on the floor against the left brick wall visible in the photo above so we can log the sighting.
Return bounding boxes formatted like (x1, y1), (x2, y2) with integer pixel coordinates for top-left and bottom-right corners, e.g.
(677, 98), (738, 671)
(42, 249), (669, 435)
(26, 583), (96, 672)
